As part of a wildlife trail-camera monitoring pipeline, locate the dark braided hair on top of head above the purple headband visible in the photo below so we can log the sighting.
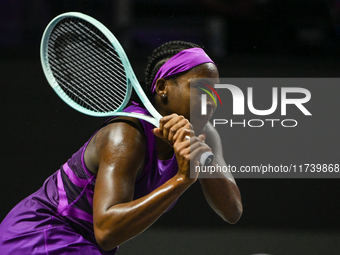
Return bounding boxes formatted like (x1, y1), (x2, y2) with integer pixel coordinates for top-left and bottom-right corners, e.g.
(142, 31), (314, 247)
(142, 41), (201, 98)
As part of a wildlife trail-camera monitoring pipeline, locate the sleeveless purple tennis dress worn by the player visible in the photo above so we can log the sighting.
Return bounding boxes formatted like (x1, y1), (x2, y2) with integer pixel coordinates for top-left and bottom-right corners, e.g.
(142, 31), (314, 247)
(0, 105), (178, 255)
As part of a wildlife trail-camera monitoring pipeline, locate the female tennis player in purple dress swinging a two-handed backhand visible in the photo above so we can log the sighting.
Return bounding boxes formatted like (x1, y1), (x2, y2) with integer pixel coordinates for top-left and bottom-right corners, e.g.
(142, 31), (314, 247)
(0, 41), (242, 255)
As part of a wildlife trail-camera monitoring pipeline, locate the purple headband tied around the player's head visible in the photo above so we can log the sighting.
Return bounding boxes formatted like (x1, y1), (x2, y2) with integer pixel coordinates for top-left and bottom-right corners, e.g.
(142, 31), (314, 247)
(151, 48), (215, 93)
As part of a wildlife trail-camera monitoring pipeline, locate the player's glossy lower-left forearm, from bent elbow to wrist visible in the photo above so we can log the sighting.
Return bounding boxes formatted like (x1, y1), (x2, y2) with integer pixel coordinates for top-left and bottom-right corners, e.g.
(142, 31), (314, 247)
(95, 176), (191, 250)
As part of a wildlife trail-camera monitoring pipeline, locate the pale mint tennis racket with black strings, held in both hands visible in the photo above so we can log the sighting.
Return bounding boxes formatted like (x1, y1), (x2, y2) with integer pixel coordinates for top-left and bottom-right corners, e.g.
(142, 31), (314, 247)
(40, 12), (214, 165)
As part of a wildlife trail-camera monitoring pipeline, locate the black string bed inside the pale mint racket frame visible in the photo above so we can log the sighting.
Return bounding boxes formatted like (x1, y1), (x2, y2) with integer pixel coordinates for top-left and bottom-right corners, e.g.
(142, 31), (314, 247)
(48, 18), (127, 112)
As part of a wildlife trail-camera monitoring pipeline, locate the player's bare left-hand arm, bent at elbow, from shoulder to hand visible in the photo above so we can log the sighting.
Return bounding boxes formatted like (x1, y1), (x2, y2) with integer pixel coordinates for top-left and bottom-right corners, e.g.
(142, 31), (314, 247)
(88, 117), (209, 250)
